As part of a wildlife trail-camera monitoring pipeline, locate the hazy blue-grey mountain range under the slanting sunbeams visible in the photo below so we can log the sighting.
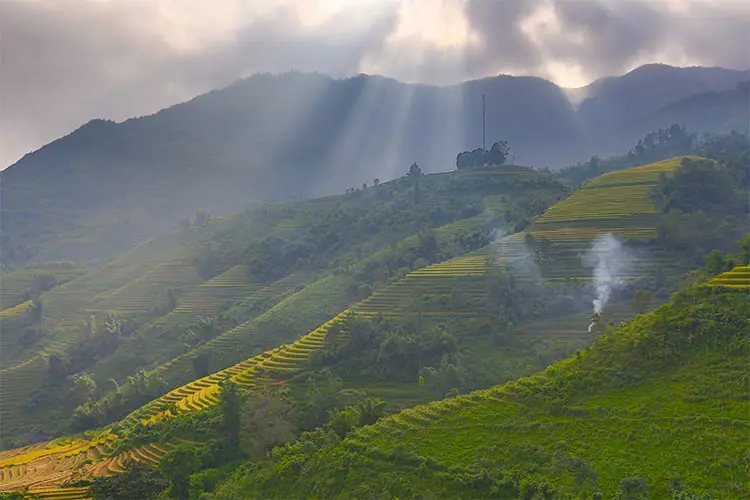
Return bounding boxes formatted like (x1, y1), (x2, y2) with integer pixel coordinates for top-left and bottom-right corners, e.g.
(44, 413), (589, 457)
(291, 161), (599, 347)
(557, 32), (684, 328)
(0, 65), (747, 274)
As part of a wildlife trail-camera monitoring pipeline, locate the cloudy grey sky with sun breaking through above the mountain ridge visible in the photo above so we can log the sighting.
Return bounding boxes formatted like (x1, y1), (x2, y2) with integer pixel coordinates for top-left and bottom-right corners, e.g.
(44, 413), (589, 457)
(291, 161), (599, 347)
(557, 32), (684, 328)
(0, 0), (750, 169)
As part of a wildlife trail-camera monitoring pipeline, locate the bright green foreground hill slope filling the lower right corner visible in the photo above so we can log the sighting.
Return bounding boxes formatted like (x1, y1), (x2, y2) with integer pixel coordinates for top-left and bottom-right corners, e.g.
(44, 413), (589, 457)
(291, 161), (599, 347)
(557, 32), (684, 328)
(212, 287), (750, 499)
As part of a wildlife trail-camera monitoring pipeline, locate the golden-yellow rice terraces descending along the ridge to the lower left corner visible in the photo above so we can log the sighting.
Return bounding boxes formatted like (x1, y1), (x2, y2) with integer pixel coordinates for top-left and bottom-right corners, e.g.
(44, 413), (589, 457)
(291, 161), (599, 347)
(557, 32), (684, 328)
(0, 252), (500, 498)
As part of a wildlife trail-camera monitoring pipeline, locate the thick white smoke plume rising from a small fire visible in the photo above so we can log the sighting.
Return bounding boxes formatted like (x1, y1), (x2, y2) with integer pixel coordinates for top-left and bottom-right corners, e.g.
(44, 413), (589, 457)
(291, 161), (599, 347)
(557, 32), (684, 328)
(582, 233), (632, 331)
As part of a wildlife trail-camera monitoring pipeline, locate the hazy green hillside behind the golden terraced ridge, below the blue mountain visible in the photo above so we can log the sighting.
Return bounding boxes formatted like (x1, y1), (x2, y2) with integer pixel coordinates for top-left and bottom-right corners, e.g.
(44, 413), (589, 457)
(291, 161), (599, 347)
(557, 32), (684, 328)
(4, 165), (565, 446)
